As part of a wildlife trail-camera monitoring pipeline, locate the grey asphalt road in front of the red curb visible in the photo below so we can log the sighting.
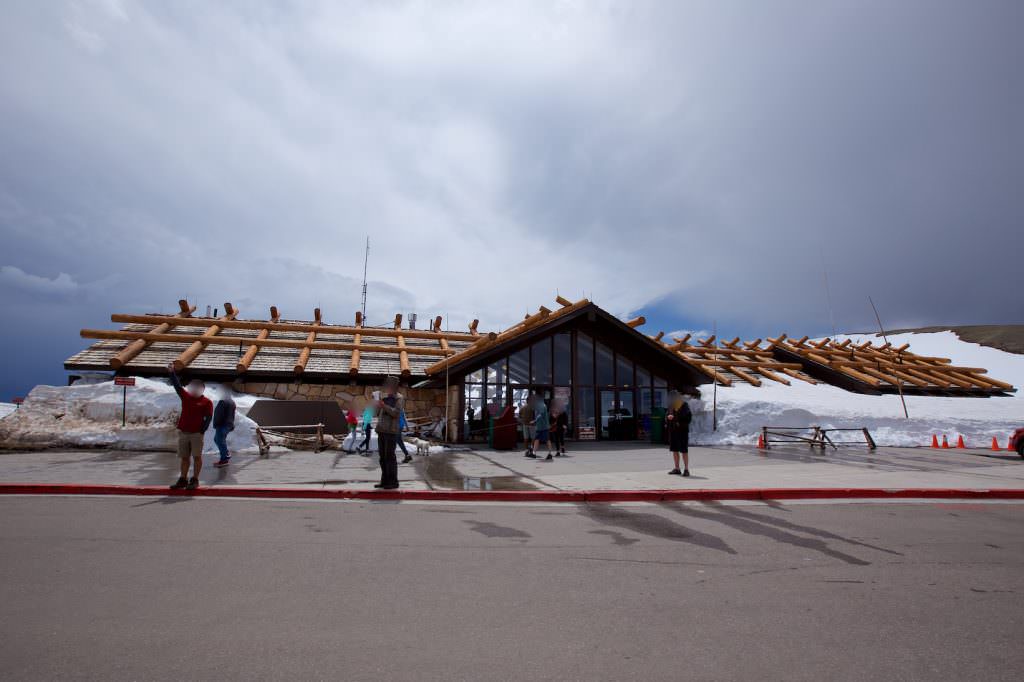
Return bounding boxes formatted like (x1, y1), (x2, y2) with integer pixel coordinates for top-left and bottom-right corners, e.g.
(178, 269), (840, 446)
(0, 497), (1024, 680)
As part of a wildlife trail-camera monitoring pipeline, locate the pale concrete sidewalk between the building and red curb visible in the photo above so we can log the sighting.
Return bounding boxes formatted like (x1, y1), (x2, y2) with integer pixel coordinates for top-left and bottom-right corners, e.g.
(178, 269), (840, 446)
(0, 443), (1024, 491)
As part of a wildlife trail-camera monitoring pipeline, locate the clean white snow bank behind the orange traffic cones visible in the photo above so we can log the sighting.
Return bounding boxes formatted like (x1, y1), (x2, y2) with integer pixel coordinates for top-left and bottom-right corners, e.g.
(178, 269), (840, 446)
(691, 332), (1024, 447)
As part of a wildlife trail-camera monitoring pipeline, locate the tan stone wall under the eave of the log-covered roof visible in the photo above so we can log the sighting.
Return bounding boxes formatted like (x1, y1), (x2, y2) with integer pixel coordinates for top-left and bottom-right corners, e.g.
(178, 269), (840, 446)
(233, 382), (459, 419)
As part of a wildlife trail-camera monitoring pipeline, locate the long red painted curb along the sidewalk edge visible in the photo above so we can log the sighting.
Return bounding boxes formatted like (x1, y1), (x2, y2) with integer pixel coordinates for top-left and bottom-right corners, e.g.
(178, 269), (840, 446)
(0, 483), (1024, 503)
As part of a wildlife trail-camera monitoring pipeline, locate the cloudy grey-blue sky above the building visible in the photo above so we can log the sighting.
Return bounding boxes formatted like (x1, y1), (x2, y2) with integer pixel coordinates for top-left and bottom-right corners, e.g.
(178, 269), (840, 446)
(0, 0), (1024, 399)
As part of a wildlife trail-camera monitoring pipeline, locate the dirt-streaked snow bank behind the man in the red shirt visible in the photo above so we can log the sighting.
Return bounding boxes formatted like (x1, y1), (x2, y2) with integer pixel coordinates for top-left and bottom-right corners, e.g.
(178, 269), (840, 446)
(0, 378), (258, 453)
